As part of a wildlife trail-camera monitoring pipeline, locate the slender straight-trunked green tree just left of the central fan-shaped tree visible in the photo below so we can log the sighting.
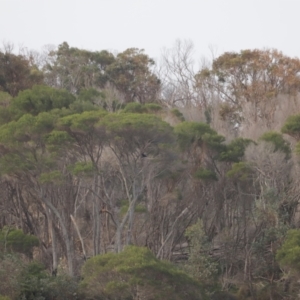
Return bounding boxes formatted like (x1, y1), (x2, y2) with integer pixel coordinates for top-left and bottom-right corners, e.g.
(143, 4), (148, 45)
(53, 110), (107, 255)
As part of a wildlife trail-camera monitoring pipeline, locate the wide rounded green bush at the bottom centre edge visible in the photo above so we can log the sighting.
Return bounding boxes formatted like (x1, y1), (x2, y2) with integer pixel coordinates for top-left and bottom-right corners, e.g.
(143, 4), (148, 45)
(80, 246), (204, 300)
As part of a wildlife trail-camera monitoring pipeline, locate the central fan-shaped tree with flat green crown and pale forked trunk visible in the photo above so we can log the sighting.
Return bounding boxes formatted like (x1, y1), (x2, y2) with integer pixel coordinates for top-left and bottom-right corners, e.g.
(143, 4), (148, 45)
(103, 113), (174, 252)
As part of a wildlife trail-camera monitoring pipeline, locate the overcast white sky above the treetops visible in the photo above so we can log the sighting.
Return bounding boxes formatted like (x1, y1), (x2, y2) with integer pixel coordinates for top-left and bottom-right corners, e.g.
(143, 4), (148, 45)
(0, 0), (300, 62)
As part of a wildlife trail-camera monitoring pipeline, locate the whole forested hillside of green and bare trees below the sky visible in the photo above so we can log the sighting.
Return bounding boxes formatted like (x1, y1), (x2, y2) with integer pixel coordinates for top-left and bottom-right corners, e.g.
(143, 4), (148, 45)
(0, 41), (300, 300)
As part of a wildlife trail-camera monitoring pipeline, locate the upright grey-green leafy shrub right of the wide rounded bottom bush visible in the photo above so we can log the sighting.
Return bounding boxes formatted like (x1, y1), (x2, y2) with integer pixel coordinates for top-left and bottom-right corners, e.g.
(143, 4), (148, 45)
(185, 220), (218, 292)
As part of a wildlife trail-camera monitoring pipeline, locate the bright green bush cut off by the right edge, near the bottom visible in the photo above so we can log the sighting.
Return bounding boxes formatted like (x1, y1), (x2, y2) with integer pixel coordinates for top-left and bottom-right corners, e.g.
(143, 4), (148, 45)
(276, 229), (300, 272)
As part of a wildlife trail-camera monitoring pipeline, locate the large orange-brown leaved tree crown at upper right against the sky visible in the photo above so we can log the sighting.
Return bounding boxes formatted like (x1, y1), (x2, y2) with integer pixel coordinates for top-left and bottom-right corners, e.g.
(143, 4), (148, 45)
(196, 49), (300, 126)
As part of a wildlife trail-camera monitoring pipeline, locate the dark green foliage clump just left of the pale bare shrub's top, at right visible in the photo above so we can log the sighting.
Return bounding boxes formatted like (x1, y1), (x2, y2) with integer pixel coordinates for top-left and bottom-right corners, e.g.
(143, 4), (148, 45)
(219, 138), (252, 162)
